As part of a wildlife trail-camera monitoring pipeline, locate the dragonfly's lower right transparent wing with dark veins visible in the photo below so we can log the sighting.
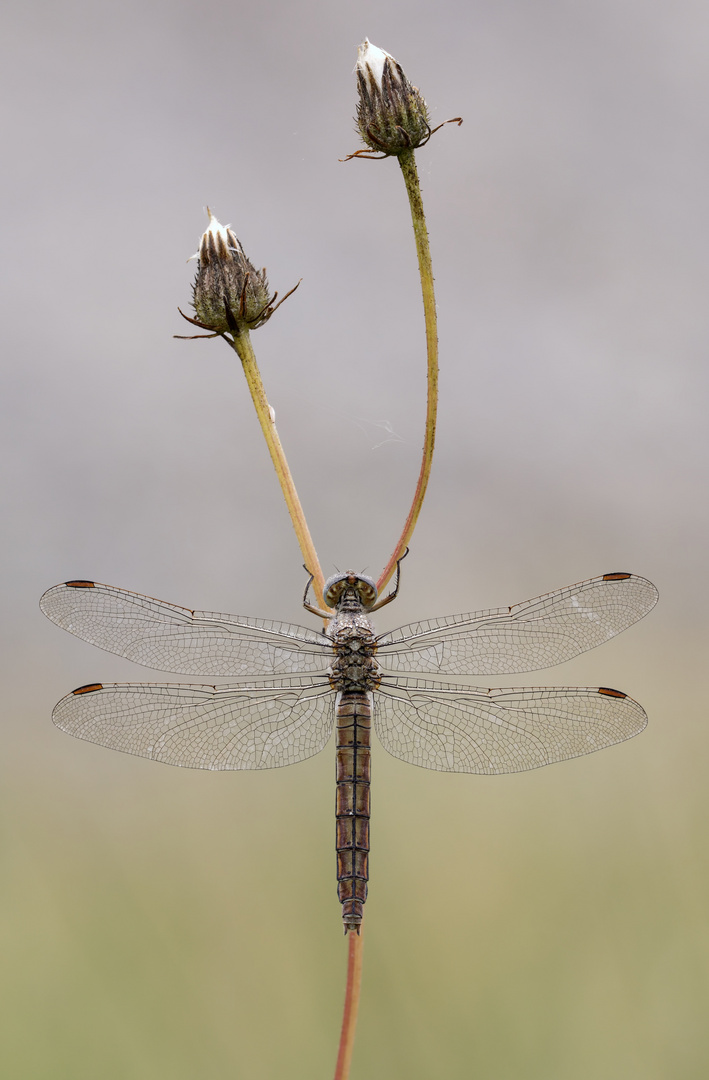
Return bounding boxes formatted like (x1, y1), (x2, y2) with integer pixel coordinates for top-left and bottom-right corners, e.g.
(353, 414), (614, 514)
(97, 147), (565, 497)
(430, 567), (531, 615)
(374, 678), (647, 774)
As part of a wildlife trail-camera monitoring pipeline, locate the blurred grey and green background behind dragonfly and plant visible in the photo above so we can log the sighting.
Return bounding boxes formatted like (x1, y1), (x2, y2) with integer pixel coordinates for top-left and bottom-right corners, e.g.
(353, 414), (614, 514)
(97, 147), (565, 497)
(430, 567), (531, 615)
(0, 0), (709, 1080)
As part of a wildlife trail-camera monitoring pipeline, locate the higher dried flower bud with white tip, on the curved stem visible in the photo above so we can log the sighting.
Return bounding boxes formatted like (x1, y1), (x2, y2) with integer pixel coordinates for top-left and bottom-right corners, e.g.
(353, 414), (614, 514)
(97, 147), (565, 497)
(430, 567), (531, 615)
(355, 38), (431, 154)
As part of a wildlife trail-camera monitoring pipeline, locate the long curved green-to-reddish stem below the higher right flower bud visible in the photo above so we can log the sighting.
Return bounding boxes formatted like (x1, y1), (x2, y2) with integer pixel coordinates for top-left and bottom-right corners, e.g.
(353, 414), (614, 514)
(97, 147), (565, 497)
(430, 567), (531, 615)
(377, 150), (438, 592)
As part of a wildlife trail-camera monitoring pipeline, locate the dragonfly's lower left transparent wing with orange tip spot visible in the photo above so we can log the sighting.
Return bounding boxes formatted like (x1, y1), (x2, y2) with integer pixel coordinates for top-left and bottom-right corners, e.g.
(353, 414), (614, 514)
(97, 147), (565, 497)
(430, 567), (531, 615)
(52, 678), (334, 769)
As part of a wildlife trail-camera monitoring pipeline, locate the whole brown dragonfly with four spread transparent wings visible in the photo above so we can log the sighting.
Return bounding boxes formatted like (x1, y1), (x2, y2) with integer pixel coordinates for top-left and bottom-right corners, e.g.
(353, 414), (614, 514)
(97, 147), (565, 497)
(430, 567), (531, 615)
(40, 566), (657, 933)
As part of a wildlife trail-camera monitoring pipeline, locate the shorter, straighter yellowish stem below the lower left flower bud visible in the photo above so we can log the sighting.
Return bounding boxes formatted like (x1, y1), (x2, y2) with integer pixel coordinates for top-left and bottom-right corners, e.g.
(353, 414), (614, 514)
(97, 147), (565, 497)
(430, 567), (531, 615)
(226, 329), (324, 599)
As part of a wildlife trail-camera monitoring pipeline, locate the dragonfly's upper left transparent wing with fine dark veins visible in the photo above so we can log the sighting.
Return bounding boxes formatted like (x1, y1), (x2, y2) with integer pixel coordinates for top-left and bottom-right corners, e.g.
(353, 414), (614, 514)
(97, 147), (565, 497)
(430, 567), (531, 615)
(40, 581), (332, 677)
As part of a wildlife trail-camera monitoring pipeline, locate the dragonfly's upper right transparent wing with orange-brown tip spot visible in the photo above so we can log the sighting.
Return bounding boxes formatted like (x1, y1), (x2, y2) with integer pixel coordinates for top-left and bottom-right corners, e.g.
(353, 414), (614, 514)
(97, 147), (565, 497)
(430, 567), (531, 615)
(377, 573), (657, 675)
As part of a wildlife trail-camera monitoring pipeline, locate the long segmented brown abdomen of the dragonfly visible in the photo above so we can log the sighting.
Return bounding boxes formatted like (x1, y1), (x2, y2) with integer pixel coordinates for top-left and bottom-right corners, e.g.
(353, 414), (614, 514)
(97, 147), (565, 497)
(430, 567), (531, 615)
(335, 690), (372, 933)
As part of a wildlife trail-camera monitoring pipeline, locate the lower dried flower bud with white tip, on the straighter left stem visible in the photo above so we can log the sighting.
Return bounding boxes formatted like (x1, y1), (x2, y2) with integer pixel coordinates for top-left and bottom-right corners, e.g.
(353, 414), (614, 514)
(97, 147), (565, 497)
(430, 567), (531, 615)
(192, 206), (276, 334)
